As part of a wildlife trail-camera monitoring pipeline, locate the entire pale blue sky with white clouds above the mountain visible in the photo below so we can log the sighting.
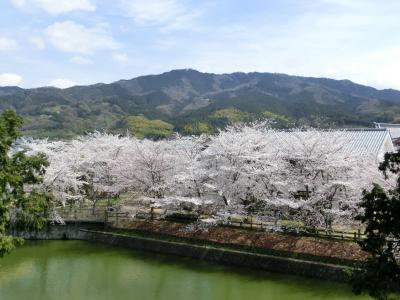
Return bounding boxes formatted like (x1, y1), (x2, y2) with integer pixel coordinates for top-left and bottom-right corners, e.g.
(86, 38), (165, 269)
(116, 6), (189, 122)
(0, 0), (400, 89)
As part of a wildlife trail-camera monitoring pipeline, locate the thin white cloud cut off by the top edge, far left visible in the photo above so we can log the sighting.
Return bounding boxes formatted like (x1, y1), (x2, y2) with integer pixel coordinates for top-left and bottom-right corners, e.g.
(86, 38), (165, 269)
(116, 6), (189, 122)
(11, 0), (96, 15)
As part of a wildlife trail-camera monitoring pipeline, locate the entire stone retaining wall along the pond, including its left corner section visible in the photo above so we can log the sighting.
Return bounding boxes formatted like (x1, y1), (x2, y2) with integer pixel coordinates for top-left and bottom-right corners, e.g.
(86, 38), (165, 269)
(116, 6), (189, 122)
(12, 222), (350, 282)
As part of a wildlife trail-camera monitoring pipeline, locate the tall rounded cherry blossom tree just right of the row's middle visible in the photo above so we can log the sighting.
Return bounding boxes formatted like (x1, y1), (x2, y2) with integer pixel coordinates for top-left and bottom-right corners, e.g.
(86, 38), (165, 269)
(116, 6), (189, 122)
(204, 123), (282, 211)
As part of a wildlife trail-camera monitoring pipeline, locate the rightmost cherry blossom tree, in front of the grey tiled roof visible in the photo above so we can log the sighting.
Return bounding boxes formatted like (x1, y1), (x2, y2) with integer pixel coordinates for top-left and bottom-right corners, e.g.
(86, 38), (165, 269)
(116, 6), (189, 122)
(274, 130), (383, 228)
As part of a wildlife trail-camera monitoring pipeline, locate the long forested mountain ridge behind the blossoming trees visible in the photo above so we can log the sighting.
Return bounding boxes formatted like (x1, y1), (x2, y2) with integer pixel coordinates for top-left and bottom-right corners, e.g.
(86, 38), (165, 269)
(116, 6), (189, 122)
(0, 69), (400, 137)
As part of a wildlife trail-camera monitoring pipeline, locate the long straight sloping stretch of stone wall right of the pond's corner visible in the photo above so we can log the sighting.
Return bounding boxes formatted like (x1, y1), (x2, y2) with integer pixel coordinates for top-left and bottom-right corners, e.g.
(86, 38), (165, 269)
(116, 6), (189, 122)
(82, 229), (350, 282)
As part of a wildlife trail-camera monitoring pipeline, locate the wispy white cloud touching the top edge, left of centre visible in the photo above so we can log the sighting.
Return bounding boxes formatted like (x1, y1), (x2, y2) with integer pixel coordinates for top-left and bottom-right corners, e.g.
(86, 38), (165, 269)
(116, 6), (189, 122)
(120, 0), (200, 31)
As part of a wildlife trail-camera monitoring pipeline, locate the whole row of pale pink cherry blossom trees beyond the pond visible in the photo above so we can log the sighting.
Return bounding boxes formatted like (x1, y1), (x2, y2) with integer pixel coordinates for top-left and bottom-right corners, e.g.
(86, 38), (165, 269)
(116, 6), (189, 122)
(21, 123), (390, 229)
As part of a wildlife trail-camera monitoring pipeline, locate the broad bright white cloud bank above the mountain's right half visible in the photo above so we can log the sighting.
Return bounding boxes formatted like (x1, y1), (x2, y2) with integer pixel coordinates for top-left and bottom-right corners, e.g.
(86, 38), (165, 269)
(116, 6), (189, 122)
(156, 0), (400, 89)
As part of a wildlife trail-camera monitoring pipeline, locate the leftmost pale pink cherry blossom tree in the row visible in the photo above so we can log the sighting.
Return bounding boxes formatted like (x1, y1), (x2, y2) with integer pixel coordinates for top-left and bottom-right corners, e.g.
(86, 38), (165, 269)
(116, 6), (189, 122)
(20, 133), (128, 208)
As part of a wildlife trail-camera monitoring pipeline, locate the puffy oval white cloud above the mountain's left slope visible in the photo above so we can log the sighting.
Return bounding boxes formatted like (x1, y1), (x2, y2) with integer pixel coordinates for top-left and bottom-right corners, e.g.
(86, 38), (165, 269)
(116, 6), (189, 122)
(45, 21), (119, 54)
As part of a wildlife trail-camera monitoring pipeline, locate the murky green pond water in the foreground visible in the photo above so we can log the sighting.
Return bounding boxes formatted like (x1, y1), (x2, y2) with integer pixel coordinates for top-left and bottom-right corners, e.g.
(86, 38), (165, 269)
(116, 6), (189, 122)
(0, 241), (365, 300)
